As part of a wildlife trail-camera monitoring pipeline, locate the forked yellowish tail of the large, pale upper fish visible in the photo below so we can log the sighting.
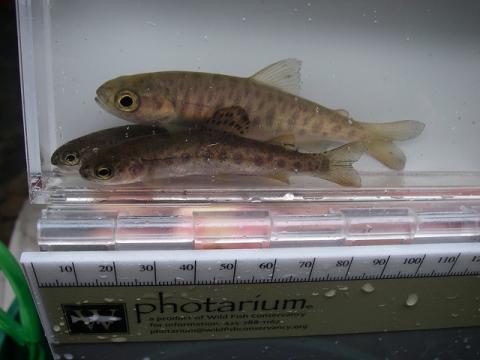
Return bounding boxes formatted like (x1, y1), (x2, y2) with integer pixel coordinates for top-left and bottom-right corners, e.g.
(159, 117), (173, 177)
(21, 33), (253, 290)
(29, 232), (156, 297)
(360, 120), (425, 170)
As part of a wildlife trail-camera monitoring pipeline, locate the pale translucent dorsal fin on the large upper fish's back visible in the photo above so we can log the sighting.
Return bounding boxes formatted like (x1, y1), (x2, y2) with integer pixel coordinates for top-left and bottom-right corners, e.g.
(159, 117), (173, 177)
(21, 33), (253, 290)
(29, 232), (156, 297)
(250, 59), (302, 95)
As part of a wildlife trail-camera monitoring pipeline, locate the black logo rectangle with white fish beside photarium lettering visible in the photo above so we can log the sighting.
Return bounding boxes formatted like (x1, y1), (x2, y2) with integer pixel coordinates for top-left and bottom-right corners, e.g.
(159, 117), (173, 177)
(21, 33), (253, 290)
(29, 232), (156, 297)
(62, 303), (128, 334)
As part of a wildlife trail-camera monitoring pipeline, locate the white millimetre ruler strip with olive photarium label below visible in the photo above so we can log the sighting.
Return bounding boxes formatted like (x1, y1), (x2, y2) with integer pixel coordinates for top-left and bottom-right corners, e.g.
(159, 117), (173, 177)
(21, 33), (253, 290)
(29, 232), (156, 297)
(21, 243), (480, 343)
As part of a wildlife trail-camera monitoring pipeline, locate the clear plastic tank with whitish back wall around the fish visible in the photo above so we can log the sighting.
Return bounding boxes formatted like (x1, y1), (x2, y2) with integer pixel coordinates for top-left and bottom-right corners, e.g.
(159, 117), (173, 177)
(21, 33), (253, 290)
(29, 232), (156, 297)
(17, 0), (480, 203)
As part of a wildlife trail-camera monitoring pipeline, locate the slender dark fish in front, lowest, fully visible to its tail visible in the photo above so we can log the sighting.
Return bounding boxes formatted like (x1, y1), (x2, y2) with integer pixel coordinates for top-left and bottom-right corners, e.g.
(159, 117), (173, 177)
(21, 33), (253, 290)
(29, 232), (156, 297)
(79, 131), (364, 187)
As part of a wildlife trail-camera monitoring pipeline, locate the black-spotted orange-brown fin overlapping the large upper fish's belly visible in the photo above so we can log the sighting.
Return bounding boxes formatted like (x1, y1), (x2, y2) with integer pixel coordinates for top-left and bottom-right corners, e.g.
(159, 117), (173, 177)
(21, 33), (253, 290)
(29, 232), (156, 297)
(206, 106), (250, 136)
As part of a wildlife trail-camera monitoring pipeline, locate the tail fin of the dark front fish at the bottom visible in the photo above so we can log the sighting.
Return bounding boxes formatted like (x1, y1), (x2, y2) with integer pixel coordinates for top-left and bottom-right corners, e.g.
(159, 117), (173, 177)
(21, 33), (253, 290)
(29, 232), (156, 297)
(322, 142), (365, 187)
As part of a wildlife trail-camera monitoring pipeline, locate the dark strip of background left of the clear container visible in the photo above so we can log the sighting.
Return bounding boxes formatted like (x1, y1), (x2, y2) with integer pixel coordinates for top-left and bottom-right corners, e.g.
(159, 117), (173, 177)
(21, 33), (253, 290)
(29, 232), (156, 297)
(0, 0), (27, 243)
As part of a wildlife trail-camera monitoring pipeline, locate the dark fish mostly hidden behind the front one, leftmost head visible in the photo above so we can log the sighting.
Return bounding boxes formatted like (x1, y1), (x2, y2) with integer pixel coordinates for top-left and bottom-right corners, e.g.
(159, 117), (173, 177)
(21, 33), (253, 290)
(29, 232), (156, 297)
(50, 125), (167, 169)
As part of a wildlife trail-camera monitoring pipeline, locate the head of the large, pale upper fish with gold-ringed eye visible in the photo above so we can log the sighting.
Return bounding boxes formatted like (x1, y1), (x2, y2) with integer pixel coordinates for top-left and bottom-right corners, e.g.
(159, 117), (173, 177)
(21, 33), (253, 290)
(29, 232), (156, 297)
(95, 74), (175, 124)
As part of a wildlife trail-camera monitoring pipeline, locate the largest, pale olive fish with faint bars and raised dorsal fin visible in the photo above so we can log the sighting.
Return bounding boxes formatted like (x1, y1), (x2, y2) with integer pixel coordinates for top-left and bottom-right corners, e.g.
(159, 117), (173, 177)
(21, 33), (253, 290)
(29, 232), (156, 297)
(95, 59), (425, 170)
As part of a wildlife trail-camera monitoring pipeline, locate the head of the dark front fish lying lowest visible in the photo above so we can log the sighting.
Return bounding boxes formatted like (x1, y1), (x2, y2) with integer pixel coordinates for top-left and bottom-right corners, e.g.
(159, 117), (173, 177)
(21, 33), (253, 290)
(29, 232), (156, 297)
(79, 152), (146, 185)
